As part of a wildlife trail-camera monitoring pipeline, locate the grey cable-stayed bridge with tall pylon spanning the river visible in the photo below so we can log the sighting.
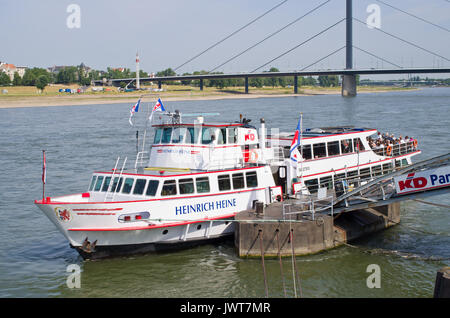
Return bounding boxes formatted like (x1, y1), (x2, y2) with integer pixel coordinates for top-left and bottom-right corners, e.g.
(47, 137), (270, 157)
(93, 0), (450, 96)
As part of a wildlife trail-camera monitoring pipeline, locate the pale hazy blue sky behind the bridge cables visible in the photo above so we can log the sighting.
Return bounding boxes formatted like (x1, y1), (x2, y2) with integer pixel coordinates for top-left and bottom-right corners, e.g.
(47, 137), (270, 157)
(0, 0), (450, 77)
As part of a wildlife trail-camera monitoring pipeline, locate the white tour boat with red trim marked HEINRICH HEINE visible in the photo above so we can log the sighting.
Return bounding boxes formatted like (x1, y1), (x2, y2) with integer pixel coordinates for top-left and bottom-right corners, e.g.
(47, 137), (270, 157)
(35, 111), (420, 258)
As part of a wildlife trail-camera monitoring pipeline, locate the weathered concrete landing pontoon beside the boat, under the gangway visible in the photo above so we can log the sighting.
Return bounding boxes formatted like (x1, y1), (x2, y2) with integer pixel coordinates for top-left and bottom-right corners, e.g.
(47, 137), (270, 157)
(235, 201), (400, 258)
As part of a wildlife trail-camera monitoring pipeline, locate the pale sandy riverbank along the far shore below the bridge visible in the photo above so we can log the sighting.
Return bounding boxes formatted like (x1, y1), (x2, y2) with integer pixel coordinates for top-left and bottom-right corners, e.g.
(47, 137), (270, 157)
(0, 87), (414, 108)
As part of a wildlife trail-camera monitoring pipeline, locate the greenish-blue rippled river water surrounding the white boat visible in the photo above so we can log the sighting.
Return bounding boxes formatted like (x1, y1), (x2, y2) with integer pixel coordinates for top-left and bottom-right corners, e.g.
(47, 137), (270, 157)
(0, 88), (450, 298)
